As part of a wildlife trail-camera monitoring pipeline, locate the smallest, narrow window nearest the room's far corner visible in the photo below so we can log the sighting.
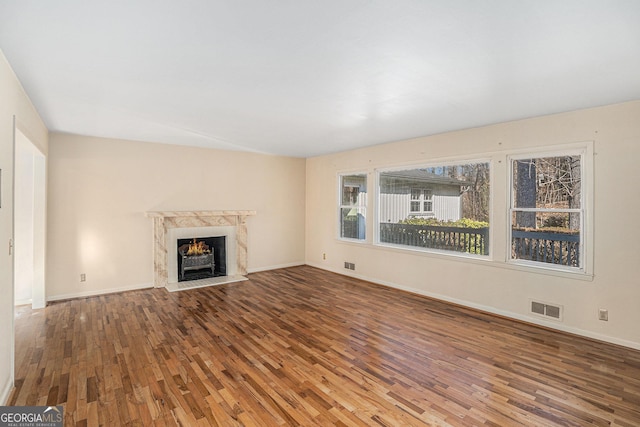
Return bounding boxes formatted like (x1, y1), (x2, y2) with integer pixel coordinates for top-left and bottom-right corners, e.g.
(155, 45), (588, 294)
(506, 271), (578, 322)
(340, 174), (367, 240)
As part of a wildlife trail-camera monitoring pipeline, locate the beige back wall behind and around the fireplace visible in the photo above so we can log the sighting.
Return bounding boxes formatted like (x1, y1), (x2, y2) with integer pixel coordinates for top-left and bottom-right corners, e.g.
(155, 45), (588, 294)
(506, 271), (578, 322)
(47, 134), (305, 300)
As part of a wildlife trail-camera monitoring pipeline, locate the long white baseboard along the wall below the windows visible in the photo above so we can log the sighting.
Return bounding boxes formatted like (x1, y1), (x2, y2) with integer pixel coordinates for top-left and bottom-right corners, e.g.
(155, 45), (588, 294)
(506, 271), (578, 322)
(307, 263), (640, 350)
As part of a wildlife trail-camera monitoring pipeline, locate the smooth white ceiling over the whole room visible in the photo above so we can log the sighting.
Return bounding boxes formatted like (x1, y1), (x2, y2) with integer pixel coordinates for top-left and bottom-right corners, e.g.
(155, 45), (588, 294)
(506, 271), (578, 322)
(0, 0), (640, 157)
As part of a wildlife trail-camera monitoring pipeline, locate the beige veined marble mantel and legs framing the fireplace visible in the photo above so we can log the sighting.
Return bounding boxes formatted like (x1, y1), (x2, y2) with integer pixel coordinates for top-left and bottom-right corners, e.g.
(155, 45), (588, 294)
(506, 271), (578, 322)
(146, 211), (256, 288)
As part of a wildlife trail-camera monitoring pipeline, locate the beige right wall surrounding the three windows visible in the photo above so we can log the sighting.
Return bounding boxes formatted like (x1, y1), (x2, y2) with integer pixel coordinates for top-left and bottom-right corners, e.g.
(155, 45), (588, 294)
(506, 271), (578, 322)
(306, 102), (640, 348)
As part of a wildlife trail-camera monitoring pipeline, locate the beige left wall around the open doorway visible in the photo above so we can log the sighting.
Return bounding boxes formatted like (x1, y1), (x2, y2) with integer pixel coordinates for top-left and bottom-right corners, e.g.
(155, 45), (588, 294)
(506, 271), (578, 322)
(0, 52), (48, 404)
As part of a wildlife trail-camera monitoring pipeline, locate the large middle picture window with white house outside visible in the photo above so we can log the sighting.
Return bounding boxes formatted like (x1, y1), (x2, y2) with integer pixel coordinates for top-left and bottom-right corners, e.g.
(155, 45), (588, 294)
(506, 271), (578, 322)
(377, 162), (490, 255)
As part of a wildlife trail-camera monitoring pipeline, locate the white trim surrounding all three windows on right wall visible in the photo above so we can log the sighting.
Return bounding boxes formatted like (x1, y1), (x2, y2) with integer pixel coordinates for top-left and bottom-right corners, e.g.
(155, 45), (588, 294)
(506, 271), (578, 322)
(334, 145), (596, 281)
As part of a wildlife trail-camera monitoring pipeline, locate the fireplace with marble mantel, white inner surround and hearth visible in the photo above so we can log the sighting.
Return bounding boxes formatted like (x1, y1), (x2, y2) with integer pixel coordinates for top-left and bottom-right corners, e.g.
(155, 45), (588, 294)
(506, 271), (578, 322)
(145, 211), (256, 292)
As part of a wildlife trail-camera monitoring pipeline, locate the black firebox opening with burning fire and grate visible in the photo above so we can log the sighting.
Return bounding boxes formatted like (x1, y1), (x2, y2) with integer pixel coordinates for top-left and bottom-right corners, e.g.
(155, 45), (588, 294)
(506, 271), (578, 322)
(177, 236), (227, 282)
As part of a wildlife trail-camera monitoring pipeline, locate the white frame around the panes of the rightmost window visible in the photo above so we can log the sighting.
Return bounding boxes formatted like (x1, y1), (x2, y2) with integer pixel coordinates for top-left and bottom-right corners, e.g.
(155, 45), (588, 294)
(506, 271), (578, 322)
(505, 145), (594, 276)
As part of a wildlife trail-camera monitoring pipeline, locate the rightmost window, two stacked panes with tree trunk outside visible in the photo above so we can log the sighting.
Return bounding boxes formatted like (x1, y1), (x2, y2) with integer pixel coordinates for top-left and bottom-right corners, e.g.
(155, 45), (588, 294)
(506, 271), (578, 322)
(510, 151), (585, 269)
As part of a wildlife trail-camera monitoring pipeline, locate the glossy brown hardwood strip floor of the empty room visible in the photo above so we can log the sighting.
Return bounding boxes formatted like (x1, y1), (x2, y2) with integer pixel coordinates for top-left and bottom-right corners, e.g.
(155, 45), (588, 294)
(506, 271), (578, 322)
(8, 267), (640, 426)
